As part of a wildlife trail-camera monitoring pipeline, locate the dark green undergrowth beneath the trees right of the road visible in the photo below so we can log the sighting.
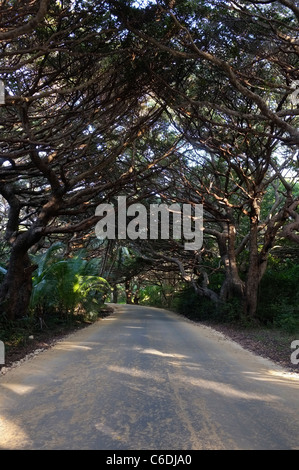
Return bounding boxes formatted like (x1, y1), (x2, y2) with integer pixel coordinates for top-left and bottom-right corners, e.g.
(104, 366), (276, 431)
(172, 260), (299, 334)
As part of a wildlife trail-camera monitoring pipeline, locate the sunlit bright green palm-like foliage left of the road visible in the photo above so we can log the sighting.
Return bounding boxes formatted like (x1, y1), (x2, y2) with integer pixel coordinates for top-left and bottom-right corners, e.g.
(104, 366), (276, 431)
(30, 243), (110, 316)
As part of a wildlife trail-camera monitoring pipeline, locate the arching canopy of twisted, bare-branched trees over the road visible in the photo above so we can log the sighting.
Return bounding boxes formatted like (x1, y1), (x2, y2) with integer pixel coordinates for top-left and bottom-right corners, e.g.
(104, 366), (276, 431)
(0, 0), (299, 319)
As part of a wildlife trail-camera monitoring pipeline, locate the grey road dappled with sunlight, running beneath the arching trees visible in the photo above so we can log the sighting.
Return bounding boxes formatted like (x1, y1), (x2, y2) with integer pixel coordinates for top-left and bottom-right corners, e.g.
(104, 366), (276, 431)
(0, 306), (299, 450)
